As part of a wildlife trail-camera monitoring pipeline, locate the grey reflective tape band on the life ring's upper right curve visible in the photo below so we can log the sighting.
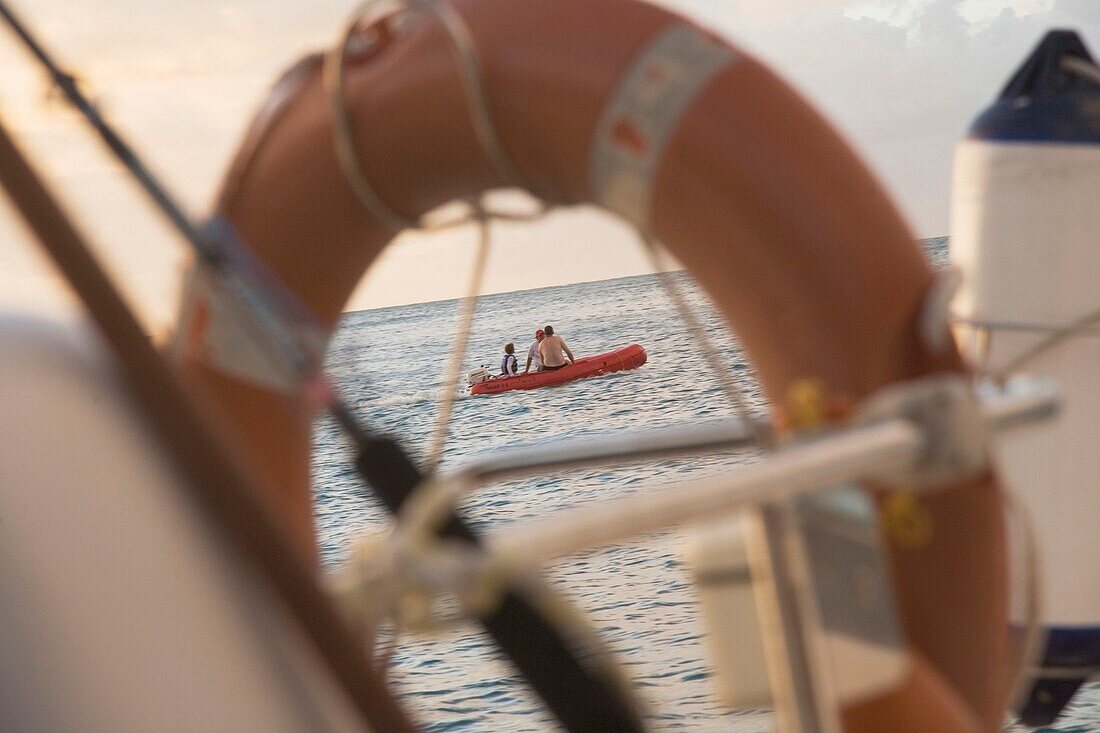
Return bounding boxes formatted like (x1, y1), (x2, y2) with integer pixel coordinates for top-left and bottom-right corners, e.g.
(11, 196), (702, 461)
(590, 25), (736, 228)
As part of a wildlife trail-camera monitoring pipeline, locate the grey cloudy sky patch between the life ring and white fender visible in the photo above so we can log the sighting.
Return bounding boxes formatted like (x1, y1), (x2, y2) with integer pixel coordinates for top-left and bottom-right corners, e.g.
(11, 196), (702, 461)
(646, 0), (1100, 237)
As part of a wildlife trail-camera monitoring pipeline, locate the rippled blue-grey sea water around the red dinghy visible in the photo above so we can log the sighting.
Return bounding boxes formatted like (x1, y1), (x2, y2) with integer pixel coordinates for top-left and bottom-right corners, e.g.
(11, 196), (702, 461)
(315, 240), (1100, 733)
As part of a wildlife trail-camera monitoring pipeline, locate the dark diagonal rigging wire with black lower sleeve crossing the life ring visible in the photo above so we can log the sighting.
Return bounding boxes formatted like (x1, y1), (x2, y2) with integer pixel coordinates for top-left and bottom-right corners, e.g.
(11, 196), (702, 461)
(0, 3), (642, 731)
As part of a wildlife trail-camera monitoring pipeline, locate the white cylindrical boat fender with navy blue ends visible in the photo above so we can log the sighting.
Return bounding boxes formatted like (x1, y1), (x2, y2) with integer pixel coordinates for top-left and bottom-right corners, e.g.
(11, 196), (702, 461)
(950, 31), (1100, 725)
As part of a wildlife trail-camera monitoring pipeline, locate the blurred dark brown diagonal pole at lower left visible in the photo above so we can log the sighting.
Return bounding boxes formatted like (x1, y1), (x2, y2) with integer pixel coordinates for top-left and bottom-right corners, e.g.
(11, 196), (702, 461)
(0, 75), (413, 733)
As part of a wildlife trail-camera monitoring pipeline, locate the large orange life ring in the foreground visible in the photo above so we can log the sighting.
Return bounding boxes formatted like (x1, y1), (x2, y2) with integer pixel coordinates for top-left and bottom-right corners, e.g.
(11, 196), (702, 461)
(182, 0), (1009, 733)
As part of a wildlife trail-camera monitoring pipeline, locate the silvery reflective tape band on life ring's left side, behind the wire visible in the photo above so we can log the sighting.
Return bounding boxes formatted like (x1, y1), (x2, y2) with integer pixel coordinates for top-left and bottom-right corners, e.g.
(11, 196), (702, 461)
(171, 259), (328, 394)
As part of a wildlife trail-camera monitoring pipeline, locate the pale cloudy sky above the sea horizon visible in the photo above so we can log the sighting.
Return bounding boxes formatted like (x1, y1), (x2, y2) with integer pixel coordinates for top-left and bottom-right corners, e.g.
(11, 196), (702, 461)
(0, 0), (1100, 331)
